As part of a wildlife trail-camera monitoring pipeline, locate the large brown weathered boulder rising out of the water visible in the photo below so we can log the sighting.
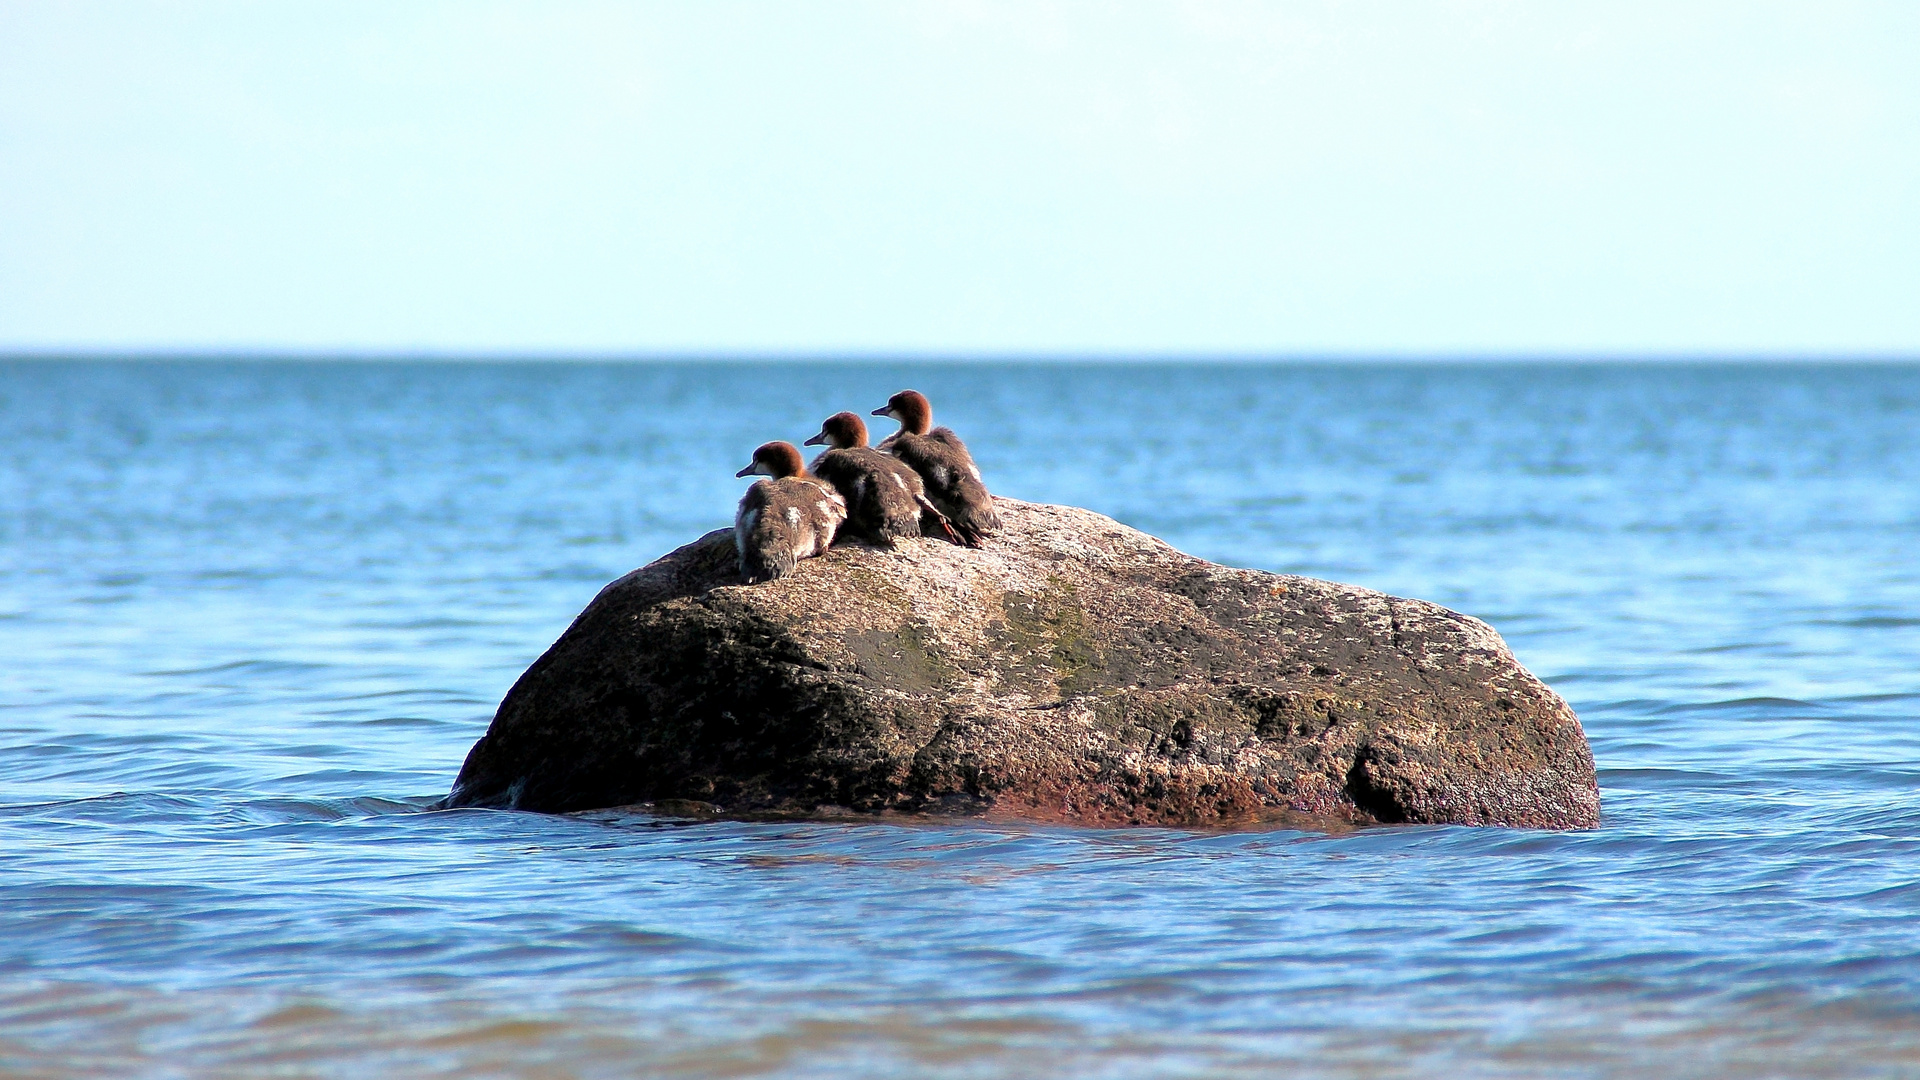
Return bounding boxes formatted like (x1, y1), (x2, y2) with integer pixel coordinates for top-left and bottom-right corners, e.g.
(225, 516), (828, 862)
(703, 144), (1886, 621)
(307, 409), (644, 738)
(445, 500), (1599, 828)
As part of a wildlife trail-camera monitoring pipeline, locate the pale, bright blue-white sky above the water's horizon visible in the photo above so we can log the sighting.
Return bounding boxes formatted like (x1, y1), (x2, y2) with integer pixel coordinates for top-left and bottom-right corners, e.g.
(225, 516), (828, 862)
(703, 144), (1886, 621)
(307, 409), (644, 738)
(0, 0), (1920, 356)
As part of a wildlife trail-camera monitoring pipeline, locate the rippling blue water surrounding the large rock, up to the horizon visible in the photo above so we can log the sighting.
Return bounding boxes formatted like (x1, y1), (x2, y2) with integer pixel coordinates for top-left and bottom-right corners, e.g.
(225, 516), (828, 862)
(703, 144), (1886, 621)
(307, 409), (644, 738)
(0, 361), (1920, 1078)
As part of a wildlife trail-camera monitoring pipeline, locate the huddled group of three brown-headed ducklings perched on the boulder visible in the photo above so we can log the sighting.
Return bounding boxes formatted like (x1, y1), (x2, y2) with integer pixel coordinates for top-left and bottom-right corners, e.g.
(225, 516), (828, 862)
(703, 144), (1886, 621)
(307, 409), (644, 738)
(733, 390), (1000, 584)
